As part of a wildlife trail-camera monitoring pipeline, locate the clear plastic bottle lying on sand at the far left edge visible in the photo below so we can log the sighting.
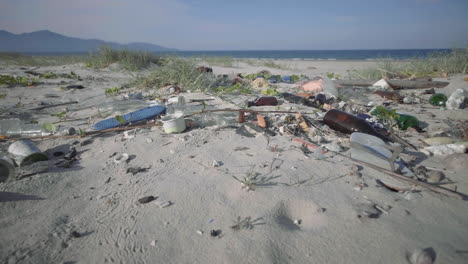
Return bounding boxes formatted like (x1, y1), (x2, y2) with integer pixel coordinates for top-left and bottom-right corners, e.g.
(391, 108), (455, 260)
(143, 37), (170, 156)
(0, 119), (51, 137)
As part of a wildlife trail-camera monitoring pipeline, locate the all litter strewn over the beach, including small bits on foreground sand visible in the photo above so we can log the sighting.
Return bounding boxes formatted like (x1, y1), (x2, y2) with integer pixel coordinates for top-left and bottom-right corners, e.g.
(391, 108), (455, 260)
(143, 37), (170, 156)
(0, 66), (468, 258)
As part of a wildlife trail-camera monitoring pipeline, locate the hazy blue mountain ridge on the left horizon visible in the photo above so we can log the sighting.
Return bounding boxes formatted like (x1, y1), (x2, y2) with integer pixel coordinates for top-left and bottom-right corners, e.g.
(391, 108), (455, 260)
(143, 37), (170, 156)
(0, 30), (175, 53)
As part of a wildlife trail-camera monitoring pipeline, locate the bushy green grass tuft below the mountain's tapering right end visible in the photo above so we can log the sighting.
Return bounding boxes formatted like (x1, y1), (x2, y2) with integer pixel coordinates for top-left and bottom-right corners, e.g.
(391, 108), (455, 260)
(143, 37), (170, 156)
(86, 46), (162, 71)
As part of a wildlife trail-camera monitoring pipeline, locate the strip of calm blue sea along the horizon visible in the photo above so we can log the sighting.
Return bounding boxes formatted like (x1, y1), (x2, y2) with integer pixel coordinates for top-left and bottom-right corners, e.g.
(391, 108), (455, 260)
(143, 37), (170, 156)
(30, 49), (450, 60)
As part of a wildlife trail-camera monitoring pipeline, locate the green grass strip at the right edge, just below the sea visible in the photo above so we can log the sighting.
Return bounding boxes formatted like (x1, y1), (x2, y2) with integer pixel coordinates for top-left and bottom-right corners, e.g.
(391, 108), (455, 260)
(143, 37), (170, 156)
(350, 47), (468, 79)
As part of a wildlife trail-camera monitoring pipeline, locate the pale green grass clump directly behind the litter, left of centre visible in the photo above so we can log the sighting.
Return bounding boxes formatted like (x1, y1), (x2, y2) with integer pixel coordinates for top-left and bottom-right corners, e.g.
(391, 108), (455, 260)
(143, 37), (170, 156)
(134, 57), (216, 91)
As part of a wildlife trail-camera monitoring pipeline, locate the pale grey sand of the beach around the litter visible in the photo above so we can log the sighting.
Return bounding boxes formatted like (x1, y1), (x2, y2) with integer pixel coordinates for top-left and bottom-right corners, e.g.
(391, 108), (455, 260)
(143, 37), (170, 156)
(0, 60), (468, 264)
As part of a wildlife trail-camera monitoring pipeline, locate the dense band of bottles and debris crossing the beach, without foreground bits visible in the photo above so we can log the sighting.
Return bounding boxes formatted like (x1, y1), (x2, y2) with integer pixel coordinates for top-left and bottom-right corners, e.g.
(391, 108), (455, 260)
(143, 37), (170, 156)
(0, 66), (468, 196)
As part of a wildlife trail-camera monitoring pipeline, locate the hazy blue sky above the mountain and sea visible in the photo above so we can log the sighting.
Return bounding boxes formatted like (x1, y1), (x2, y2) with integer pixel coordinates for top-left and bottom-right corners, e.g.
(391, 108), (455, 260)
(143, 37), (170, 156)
(0, 0), (468, 50)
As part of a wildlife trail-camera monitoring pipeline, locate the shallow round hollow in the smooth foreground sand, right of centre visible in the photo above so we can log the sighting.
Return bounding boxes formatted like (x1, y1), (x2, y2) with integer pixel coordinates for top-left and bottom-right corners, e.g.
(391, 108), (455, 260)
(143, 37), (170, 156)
(270, 200), (327, 231)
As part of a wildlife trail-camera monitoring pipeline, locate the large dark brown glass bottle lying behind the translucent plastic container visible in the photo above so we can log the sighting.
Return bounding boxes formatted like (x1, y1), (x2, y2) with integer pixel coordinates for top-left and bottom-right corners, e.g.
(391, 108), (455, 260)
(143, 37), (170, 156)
(323, 109), (389, 141)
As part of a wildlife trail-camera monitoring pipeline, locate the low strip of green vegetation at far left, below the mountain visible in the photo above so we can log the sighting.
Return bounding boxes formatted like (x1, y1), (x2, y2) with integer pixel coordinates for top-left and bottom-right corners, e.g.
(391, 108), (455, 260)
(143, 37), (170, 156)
(0, 52), (86, 66)
